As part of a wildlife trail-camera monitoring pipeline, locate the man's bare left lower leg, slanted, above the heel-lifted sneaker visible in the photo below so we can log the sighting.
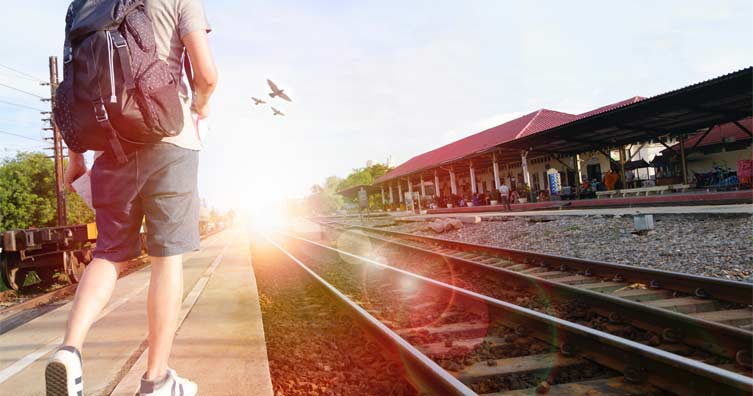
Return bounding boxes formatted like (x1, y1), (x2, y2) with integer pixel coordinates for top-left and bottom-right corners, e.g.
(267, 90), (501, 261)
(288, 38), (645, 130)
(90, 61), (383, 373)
(63, 258), (122, 350)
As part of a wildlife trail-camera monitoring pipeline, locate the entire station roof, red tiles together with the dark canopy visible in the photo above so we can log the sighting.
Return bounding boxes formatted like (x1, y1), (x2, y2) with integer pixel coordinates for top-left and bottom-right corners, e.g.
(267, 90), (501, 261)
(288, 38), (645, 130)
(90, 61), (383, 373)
(374, 68), (753, 184)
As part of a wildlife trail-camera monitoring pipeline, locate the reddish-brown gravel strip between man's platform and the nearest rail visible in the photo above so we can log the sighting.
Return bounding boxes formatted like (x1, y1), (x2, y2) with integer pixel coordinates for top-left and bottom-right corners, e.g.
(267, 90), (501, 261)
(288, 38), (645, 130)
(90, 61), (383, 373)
(253, 240), (416, 396)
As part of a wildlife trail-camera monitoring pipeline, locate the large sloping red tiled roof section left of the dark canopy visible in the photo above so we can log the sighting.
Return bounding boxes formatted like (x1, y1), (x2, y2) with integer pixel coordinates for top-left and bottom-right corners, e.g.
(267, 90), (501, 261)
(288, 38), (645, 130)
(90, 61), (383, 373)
(374, 109), (577, 183)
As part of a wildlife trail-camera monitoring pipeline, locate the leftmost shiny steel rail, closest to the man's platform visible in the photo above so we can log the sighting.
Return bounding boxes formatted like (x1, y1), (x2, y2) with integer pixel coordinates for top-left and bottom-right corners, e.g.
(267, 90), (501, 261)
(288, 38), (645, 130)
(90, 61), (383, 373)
(264, 235), (476, 395)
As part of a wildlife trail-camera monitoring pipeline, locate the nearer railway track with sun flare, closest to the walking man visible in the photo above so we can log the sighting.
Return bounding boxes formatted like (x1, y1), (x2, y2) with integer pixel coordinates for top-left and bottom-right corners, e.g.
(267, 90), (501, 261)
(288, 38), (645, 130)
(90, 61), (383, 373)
(273, 235), (753, 396)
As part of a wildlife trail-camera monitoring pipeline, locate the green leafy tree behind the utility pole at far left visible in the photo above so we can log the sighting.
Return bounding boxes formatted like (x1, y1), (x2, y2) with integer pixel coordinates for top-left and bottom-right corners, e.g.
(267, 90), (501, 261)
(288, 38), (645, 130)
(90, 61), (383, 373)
(0, 153), (94, 230)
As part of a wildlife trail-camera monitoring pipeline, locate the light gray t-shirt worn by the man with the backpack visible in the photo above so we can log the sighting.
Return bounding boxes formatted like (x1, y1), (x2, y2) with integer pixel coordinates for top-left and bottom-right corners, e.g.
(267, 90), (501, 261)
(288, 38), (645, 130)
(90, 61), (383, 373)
(145, 0), (210, 150)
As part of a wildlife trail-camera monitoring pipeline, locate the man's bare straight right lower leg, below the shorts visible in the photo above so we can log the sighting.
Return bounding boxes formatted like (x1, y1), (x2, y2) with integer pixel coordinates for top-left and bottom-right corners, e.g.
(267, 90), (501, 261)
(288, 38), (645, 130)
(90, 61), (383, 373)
(144, 255), (183, 380)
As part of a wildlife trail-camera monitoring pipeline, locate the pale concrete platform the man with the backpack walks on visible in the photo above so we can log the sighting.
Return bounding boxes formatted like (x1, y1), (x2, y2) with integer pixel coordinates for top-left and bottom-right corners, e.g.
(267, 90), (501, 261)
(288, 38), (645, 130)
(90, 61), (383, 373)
(0, 228), (272, 395)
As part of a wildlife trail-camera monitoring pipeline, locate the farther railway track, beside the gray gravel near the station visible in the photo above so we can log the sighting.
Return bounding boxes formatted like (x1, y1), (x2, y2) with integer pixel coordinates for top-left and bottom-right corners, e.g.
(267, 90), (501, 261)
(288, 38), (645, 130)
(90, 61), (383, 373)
(318, 224), (753, 376)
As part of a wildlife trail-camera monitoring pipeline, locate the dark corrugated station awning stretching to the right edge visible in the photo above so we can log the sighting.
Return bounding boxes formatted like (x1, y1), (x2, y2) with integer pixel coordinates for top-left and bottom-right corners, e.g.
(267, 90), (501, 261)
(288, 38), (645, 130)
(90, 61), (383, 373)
(498, 67), (753, 158)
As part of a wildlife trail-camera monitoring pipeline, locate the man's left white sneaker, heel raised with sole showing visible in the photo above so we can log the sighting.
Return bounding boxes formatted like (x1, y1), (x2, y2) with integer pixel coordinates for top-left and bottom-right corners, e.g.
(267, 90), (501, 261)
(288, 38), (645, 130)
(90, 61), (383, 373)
(44, 346), (84, 396)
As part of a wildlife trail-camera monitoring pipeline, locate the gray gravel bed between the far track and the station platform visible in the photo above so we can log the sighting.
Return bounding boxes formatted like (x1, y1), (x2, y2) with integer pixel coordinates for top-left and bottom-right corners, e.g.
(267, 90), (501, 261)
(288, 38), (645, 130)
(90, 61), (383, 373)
(385, 214), (753, 283)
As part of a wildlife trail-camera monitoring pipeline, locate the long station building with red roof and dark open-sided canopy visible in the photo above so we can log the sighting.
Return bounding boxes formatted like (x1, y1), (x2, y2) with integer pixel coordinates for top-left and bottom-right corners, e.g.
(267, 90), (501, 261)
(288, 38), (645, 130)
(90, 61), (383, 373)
(340, 68), (753, 210)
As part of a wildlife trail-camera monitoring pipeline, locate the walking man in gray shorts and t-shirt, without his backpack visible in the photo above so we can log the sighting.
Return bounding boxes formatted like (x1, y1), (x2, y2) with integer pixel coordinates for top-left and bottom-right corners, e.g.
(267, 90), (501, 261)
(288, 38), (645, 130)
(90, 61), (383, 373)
(46, 0), (217, 396)
